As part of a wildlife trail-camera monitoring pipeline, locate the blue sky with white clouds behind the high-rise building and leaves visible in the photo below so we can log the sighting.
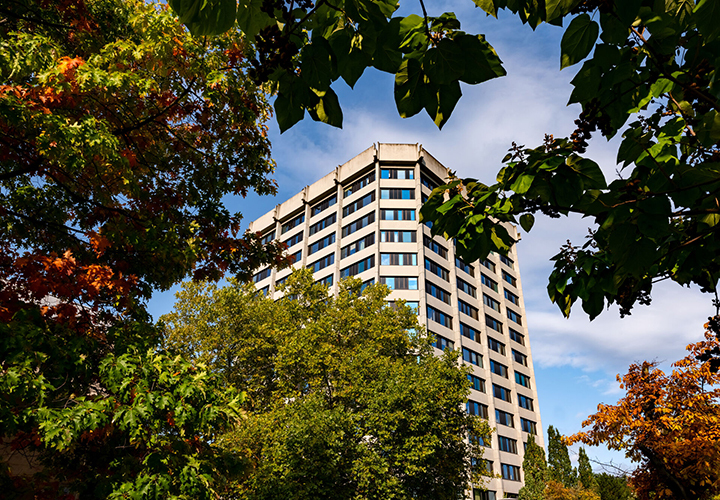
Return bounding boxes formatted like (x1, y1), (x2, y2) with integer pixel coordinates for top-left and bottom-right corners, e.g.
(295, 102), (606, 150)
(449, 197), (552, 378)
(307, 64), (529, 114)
(150, 0), (713, 476)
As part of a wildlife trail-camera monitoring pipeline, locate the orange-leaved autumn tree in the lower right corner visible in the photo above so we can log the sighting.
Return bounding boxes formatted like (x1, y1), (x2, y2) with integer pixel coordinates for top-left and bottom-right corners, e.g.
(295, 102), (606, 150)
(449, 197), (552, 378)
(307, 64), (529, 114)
(569, 317), (720, 500)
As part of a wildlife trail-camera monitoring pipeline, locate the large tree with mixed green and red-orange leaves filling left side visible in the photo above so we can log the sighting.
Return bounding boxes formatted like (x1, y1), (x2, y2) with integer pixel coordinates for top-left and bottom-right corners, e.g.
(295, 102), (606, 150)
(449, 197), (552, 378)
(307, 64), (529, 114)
(0, 0), (283, 498)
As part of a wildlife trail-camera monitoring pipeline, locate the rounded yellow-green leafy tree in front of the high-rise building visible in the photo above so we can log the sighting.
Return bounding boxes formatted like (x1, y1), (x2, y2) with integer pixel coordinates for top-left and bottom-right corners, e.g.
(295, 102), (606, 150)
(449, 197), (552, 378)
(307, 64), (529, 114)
(163, 270), (490, 499)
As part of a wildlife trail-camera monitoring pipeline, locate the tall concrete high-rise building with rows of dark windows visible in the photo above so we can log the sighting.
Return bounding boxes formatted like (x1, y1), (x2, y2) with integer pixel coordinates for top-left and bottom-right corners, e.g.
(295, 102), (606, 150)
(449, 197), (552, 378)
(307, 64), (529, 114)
(250, 144), (543, 500)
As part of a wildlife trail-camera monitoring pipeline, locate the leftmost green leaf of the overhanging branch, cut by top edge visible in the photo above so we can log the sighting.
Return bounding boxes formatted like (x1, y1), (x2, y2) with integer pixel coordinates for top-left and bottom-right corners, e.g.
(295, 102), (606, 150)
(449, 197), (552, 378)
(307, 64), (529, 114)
(169, 0), (236, 36)
